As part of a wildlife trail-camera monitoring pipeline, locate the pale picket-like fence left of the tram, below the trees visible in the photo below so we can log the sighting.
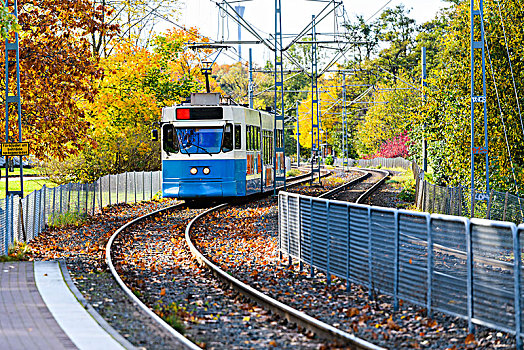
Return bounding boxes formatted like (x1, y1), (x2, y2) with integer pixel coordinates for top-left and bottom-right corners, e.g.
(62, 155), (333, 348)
(0, 171), (161, 255)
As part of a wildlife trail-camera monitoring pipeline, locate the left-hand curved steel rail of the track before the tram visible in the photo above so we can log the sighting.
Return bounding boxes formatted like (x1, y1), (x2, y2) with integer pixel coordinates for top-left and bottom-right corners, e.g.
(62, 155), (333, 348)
(106, 203), (201, 350)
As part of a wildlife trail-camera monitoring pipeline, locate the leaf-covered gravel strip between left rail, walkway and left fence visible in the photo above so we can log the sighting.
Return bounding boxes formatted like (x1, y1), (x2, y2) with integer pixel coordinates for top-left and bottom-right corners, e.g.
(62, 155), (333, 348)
(30, 200), (188, 349)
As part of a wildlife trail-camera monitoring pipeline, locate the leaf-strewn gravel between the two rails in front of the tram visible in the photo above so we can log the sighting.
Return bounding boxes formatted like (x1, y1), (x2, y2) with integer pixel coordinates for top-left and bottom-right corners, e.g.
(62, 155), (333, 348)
(113, 205), (334, 349)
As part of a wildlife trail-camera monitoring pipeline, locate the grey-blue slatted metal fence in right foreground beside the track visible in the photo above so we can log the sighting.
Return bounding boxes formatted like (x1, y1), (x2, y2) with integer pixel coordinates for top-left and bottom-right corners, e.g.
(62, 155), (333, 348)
(279, 192), (524, 349)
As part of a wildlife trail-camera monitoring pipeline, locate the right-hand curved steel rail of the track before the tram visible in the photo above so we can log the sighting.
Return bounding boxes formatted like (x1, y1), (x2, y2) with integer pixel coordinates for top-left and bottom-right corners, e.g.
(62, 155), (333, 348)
(185, 203), (384, 350)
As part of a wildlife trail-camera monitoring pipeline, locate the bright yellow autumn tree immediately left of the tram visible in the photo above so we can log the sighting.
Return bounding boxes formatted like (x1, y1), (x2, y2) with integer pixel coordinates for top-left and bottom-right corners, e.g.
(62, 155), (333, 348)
(46, 29), (216, 181)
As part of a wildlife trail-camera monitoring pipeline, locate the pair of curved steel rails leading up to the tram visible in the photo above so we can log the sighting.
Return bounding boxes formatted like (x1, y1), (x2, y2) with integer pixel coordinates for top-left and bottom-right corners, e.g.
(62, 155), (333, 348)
(106, 172), (386, 349)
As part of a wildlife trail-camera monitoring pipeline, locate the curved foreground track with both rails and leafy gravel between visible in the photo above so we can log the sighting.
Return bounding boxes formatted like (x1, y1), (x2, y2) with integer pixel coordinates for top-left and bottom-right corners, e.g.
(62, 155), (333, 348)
(106, 168), (386, 349)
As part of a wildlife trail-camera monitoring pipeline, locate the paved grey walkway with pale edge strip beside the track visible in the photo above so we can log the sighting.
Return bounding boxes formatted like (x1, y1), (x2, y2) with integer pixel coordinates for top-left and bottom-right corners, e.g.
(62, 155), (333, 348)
(0, 262), (129, 350)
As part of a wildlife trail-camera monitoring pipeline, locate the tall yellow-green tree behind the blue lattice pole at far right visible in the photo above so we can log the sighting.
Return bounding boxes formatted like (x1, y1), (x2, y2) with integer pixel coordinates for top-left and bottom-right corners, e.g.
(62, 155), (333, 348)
(416, 0), (524, 191)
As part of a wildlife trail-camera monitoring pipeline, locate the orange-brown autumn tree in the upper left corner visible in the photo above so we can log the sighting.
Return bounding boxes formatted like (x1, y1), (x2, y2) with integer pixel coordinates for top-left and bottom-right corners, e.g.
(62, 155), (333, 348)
(1, 0), (116, 159)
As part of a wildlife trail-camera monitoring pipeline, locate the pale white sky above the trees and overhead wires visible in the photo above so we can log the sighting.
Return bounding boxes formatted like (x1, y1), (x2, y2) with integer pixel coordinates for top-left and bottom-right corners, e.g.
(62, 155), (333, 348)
(176, 0), (447, 64)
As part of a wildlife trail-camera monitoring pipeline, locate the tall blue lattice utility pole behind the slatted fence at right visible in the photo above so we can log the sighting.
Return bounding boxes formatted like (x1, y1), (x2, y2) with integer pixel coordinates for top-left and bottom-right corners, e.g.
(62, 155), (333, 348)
(470, 0), (489, 217)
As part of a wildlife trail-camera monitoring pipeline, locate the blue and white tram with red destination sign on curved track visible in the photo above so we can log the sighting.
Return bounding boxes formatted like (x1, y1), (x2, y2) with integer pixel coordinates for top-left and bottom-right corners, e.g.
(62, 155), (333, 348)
(161, 94), (285, 199)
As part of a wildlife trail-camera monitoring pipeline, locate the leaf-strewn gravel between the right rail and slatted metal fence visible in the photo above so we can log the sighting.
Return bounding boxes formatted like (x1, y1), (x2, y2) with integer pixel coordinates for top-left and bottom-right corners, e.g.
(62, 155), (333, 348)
(194, 174), (515, 349)
